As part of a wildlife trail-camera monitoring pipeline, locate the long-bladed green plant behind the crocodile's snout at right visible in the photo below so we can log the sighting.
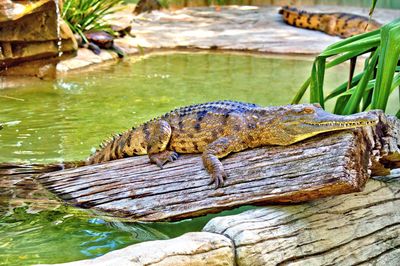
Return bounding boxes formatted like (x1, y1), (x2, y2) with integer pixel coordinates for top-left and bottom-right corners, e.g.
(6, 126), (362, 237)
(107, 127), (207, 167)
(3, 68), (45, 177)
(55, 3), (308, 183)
(292, 17), (400, 117)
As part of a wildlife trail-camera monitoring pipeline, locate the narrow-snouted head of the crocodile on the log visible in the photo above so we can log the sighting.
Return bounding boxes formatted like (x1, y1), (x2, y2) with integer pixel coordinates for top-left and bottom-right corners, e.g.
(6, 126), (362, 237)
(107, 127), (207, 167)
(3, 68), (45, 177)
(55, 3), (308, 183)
(268, 104), (378, 145)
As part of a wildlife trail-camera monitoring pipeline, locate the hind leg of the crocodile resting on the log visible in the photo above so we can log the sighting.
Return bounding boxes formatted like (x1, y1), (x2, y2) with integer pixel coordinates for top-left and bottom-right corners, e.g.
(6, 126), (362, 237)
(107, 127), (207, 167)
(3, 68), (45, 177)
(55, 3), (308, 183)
(144, 120), (178, 168)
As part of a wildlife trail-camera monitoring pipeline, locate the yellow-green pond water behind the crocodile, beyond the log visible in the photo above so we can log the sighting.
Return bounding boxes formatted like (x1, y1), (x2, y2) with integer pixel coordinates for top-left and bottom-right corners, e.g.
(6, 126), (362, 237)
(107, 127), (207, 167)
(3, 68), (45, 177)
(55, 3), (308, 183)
(0, 54), (338, 163)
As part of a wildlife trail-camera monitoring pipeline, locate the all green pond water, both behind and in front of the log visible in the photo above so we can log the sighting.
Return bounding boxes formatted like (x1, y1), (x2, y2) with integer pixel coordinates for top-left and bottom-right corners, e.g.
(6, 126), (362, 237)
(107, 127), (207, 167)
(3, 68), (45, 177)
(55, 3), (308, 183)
(0, 53), (396, 265)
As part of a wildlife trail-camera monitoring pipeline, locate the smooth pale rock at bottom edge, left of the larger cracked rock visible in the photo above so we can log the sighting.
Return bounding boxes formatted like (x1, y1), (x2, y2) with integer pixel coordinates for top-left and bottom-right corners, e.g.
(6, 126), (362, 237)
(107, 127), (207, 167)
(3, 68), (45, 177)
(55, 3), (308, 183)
(41, 232), (235, 266)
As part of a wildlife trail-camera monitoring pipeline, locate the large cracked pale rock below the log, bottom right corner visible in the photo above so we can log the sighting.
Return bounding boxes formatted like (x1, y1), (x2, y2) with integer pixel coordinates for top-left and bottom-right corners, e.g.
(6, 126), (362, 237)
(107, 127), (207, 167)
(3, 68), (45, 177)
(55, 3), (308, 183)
(203, 171), (400, 266)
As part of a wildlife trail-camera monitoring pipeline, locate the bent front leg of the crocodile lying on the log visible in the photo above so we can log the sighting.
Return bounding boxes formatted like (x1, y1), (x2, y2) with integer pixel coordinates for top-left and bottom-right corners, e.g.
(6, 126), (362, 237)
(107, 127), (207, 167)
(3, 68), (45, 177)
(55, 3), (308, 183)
(202, 137), (248, 188)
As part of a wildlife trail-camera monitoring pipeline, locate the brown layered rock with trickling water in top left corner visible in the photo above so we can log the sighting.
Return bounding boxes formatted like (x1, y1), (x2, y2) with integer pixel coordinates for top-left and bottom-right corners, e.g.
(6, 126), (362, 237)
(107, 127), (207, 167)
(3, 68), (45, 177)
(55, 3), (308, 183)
(0, 0), (77, 77)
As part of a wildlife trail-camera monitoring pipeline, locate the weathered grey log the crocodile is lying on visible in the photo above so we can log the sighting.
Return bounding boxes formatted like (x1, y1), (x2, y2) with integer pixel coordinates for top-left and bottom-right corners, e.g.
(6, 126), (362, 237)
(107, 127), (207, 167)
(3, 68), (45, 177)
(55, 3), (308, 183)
(38, 112), (400, 221)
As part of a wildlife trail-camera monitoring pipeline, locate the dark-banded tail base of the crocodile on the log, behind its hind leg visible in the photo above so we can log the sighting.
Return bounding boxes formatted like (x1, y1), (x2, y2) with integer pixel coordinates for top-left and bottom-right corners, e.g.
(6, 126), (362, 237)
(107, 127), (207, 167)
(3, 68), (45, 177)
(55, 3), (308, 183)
(86, 128), (146, 165)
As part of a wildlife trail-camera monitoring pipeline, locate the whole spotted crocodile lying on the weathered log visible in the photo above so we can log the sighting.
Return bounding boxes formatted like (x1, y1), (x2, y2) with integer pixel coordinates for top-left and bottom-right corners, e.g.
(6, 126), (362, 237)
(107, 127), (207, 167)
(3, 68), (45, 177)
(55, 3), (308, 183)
(87, 101), (377, 187)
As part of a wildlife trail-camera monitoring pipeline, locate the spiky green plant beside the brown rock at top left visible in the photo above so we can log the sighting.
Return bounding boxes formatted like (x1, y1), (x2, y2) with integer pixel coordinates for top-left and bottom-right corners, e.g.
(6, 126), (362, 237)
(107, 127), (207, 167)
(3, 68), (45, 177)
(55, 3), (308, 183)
(62, 0), (123, 42)
